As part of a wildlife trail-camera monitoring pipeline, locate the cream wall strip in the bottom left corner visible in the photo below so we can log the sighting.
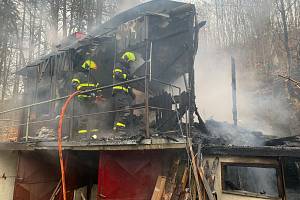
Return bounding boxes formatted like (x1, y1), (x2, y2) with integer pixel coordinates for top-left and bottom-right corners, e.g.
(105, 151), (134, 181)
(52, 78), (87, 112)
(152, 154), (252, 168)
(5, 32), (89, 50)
(0, 151), (18, 200)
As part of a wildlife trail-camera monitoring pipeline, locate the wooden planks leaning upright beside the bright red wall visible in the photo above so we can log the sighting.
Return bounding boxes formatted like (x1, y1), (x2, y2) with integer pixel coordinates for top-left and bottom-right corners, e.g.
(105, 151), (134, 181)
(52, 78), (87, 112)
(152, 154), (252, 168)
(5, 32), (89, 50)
(151, 140), (214, 200)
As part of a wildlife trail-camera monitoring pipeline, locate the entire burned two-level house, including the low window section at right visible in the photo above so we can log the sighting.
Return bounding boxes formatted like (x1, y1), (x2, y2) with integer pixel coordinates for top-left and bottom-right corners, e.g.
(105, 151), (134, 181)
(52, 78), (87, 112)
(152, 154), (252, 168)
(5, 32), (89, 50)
(0, 0), (298, 200)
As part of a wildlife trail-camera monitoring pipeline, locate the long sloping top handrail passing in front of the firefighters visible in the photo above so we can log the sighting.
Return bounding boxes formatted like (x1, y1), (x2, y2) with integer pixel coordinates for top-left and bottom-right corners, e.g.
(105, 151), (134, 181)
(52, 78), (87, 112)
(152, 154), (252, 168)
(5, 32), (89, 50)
(0, 76), (146, 115)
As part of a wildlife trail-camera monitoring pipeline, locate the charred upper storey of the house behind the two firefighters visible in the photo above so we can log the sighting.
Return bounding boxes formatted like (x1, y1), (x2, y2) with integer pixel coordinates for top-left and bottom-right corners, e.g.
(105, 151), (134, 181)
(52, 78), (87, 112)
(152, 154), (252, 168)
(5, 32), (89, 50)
(15, 1), (198, 141)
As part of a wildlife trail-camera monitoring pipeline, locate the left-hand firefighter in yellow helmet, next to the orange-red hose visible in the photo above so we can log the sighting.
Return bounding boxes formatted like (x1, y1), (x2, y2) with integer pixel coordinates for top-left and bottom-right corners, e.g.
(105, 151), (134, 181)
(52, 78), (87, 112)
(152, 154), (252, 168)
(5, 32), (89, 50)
(72, 59), (100, 139)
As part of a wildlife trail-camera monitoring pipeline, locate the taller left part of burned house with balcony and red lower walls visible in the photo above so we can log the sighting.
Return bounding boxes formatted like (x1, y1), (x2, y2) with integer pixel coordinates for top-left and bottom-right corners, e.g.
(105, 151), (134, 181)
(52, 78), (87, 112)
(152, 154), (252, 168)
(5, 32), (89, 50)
(1, 1), (200, 199)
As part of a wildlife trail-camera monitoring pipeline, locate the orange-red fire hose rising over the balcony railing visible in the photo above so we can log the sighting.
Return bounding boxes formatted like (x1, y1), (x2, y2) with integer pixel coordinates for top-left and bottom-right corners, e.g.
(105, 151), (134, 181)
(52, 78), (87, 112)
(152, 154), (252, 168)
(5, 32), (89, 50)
(57, 91), (79, 200)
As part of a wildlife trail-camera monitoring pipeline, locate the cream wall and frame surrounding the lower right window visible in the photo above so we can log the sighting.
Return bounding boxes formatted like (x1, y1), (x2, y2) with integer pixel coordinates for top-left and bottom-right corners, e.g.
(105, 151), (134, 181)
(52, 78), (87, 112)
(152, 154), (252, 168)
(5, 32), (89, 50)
(204, 156), (282, 200)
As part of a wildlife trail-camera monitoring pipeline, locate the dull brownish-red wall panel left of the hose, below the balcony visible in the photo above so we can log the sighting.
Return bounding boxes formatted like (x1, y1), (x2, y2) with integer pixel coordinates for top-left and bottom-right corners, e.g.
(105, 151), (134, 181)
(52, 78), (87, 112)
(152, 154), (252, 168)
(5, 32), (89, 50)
(13, 151), (60, 200)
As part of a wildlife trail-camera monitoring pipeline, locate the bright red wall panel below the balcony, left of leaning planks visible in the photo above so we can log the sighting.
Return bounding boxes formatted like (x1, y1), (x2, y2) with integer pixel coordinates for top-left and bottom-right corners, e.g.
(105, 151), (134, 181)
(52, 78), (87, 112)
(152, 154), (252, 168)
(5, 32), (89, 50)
(98, 151), (165, 200)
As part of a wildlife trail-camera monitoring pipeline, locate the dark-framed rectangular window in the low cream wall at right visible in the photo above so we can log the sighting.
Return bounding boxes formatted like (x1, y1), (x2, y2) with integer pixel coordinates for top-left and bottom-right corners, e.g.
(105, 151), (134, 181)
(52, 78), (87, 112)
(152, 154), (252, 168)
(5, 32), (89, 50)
(222, 163), (280, 198)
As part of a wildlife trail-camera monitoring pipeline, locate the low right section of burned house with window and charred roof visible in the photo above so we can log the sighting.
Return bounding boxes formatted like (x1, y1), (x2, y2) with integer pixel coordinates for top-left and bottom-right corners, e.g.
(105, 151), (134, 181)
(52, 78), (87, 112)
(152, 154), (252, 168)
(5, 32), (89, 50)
(201, 145), (300, 200)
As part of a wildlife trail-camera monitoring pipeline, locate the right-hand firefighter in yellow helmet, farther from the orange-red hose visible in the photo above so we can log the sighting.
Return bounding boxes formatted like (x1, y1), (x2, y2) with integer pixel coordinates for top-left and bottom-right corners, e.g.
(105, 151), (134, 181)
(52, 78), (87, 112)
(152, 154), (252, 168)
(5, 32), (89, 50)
(113, 51), (136, 133)
